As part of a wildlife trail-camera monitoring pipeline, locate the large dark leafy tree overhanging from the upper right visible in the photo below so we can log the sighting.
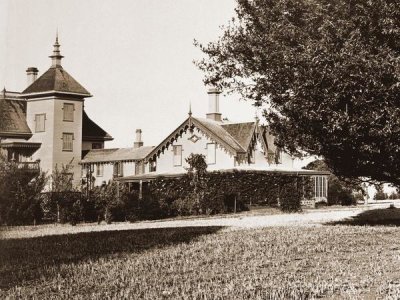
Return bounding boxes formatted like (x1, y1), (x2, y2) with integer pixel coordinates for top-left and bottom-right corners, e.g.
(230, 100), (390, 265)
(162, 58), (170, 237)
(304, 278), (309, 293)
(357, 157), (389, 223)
(197, 0), (400, 185)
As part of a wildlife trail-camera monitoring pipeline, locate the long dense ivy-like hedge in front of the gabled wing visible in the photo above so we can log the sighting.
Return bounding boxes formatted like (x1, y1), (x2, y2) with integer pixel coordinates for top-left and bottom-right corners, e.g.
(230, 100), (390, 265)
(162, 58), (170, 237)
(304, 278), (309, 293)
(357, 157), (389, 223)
(132, 171), (311, 219)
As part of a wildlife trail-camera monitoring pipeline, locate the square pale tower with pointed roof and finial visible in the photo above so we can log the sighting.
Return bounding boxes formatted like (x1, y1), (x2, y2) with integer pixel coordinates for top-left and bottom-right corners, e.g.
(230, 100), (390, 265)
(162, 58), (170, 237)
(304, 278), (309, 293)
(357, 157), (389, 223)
(22, 34), (91, 183)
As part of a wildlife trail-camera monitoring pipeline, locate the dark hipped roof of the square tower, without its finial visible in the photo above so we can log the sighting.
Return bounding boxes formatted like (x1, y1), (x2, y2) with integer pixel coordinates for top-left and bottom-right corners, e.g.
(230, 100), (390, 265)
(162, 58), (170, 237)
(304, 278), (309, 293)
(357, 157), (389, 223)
(22, 65), (91, 97)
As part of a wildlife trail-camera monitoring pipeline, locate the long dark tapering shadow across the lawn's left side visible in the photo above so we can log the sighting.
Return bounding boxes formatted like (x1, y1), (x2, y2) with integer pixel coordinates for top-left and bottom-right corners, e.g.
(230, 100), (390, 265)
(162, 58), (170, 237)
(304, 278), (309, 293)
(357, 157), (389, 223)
(0, 226), (223, 289)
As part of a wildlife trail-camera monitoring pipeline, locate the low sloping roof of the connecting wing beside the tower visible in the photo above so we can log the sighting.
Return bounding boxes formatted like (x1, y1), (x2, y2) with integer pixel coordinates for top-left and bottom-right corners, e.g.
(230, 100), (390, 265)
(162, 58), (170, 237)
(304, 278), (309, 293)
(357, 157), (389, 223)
(81, 147), (153, 164)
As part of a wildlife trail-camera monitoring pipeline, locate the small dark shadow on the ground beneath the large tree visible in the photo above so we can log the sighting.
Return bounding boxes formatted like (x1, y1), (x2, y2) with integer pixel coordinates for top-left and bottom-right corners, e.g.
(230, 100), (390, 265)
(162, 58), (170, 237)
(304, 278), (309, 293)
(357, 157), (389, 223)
(326, 208), (400, 226)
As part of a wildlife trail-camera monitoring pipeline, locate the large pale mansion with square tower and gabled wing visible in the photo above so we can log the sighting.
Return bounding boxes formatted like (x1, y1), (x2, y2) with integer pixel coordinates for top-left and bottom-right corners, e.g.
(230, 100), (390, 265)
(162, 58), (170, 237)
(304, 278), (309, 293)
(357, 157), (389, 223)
(0, 38), (328, 200)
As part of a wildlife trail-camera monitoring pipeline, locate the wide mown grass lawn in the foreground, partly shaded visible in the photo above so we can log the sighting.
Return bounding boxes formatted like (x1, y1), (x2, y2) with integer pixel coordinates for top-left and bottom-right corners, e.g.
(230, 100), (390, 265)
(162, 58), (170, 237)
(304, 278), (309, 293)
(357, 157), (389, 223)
(0, 212), (400, 299)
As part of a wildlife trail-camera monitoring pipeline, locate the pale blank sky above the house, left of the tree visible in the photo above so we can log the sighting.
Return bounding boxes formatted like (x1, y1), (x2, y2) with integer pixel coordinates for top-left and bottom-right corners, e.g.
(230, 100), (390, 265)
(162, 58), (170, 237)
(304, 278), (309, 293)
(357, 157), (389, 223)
(0, 0), (255, 148)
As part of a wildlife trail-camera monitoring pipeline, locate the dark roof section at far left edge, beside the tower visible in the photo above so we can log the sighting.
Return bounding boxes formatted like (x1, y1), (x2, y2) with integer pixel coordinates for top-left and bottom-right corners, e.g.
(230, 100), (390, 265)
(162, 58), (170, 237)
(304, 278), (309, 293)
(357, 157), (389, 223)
(0, 90), (32, 139)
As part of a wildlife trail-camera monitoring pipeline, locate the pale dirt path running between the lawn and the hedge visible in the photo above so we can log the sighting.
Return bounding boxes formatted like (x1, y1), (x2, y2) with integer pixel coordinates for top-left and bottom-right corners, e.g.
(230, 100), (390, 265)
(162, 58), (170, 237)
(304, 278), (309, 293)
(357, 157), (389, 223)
(0, 205), (388, 239)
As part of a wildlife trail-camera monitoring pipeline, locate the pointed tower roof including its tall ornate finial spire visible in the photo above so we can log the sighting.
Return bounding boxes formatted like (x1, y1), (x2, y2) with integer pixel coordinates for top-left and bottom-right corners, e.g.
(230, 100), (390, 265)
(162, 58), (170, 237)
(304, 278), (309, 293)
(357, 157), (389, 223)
(22, 33), (91, 98)
